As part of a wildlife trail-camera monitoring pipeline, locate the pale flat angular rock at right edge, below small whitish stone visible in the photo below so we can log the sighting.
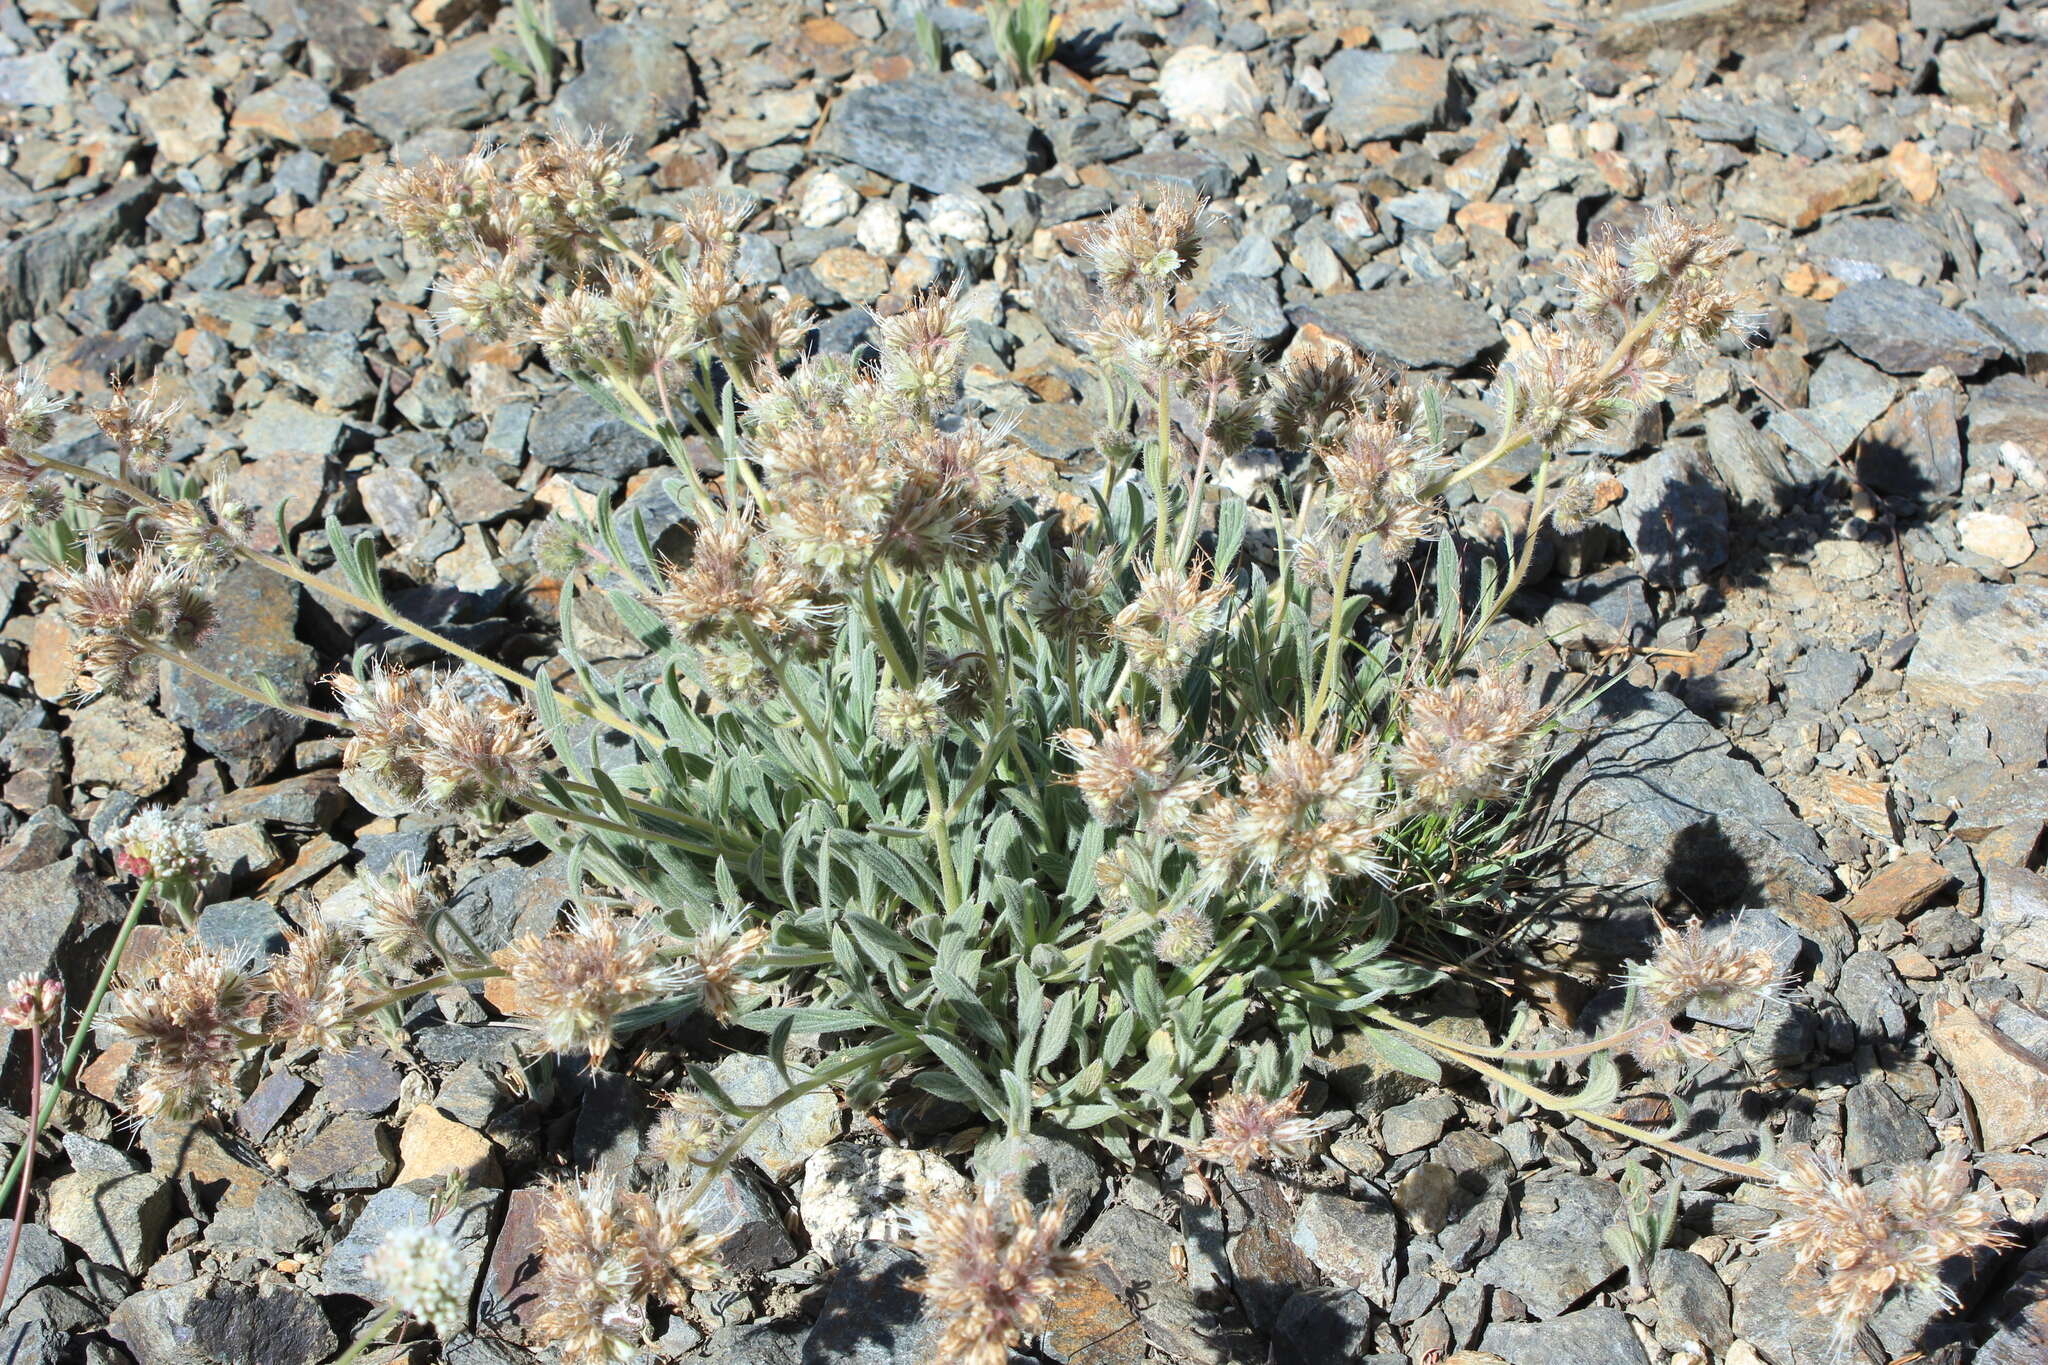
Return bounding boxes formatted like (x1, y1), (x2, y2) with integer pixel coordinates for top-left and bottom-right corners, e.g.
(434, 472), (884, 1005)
(1907, 583), (2048, 710)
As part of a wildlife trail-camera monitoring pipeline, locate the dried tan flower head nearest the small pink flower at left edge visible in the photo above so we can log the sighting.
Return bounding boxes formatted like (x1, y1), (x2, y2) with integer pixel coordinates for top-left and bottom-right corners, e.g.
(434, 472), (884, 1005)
(111, 937), (256, 1119)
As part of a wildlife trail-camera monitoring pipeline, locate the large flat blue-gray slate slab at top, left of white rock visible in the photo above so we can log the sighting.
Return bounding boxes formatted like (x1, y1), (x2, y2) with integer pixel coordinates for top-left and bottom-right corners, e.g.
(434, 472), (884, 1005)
(819, 72), (1036, 194)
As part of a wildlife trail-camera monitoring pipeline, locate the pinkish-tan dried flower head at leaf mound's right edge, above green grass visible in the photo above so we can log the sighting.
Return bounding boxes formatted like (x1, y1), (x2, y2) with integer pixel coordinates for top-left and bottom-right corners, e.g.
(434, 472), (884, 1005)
(1395, 671), (1542, 808)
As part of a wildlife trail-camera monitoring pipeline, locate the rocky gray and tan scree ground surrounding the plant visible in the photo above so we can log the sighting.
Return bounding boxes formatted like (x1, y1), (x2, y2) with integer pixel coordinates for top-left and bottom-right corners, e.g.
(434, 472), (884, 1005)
(0, 0), (2048, 1365)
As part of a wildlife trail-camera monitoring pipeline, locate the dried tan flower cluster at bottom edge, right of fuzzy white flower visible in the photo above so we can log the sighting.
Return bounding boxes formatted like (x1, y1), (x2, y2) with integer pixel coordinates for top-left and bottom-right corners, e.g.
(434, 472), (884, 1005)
(535, 1179), (719, 1365)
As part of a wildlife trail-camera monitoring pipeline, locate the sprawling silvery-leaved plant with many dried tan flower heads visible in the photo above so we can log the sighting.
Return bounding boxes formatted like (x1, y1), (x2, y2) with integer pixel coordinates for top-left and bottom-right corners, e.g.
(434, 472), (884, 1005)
(0, 139), (1997, 1361)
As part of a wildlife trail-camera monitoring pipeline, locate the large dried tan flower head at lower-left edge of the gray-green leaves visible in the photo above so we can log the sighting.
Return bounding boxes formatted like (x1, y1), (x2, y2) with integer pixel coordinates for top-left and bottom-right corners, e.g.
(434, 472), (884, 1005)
(500, 913), (696, 1066)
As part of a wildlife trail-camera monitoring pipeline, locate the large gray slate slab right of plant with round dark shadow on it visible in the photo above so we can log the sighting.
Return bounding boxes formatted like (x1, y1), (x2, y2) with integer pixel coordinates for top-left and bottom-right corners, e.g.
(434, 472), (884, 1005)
(1550, 684), (1835, 948)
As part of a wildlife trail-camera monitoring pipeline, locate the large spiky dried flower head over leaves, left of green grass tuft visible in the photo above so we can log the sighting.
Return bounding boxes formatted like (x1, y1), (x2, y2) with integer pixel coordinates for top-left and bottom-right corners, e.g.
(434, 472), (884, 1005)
(1186, 726), (1391, 909)
